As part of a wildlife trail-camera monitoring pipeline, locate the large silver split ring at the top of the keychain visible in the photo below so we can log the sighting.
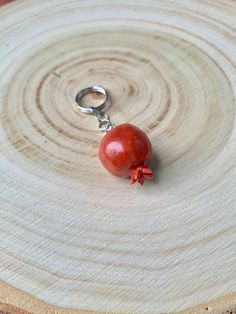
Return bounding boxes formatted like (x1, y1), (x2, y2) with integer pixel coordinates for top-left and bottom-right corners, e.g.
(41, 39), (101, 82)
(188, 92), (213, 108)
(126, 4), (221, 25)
(75, 86), (110, 114)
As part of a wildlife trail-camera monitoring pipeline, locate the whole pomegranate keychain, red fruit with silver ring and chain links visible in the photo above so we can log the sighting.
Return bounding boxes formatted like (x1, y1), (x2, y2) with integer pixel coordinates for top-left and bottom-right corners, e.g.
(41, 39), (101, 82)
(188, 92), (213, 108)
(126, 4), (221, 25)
(76, 86), (153, 185)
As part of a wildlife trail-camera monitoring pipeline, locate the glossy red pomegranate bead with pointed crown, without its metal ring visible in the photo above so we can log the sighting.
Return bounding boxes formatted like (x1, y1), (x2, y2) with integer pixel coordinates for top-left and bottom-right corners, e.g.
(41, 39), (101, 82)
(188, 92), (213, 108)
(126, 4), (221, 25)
(99, 123), (152, 184)
